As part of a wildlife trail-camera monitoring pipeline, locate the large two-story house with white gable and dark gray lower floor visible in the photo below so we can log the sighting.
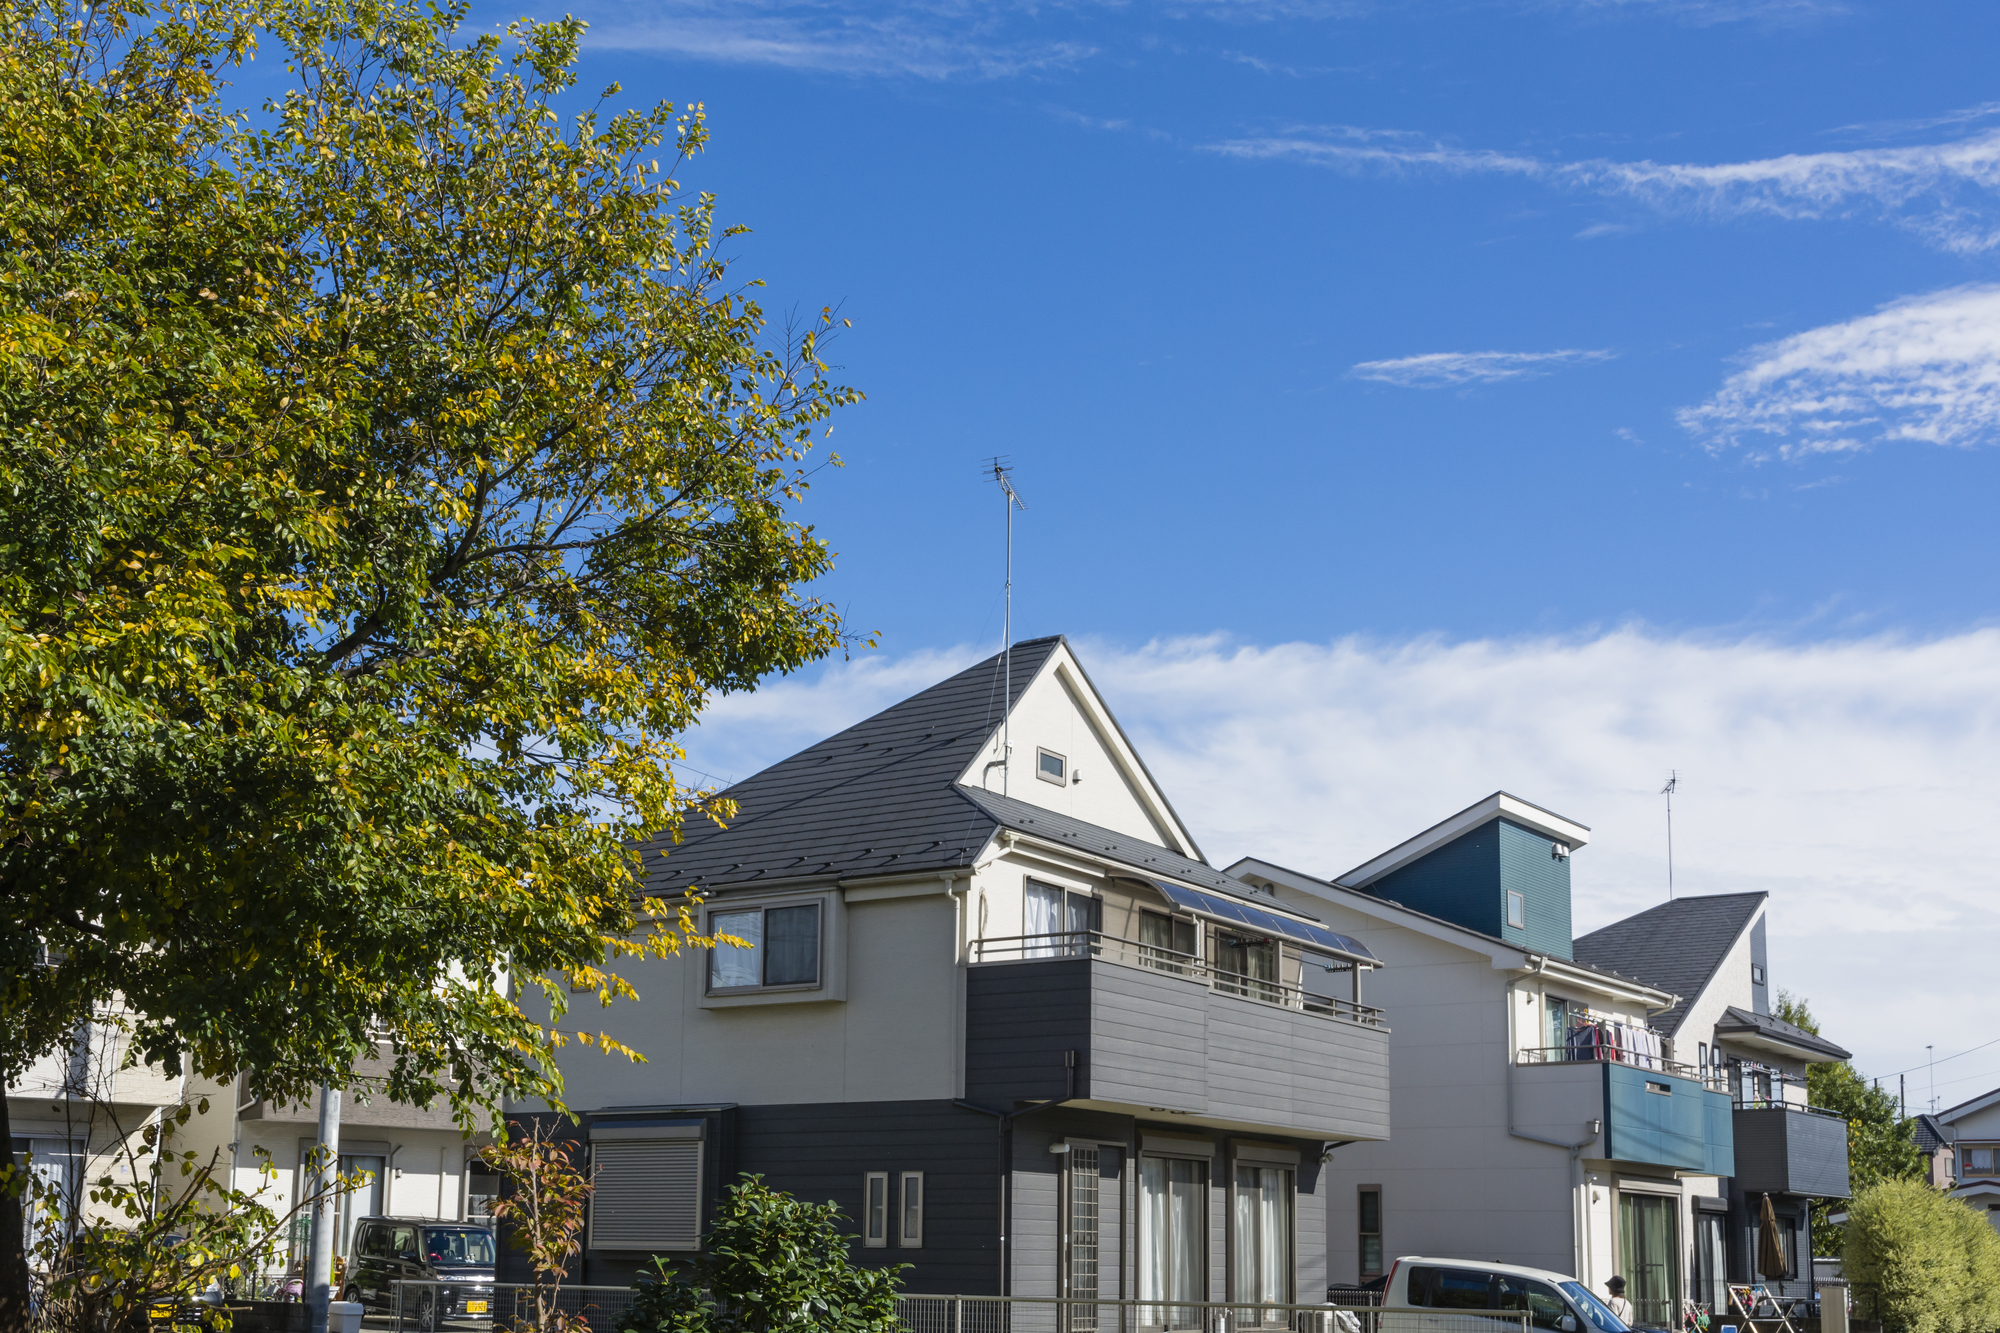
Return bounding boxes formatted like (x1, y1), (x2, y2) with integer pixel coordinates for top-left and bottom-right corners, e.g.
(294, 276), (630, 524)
(516, 638), (1390, 1327)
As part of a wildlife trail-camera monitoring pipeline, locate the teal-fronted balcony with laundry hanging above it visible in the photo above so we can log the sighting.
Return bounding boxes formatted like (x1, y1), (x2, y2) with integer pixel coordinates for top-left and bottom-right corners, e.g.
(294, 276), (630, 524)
(1514, 1047), (1736, 1175)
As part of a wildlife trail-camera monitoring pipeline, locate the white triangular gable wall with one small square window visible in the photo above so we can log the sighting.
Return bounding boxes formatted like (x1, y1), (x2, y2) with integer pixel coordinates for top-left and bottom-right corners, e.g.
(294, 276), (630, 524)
(958, 648), (1194, 857)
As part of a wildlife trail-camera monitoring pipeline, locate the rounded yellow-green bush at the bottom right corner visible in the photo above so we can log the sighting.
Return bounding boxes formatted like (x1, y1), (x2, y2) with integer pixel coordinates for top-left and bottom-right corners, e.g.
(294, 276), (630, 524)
(1842, 1181), (2000, 1333)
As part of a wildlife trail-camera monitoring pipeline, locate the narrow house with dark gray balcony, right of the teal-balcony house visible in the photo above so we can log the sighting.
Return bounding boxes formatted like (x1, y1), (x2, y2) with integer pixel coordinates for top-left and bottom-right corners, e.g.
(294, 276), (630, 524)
(1576, 893), (1848, 1313)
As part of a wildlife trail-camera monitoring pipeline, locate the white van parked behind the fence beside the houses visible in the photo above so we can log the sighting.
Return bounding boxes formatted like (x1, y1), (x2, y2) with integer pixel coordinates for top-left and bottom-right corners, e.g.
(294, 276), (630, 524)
(1382, 1255), (1630, 1333)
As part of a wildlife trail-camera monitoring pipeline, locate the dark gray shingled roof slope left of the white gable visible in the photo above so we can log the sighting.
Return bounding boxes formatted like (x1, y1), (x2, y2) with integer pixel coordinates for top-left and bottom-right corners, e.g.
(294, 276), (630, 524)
(640, 636), (1062, 895)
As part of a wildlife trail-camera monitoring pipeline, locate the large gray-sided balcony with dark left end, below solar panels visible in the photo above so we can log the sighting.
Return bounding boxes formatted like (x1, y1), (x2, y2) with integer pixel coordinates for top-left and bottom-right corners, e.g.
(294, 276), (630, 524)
(966, 931), (1388, 1139)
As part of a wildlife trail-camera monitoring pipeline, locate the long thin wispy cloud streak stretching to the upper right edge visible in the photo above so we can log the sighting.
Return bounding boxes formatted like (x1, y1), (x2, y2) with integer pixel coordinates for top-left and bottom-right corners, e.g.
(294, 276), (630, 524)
(1208, 126), (2000, 254)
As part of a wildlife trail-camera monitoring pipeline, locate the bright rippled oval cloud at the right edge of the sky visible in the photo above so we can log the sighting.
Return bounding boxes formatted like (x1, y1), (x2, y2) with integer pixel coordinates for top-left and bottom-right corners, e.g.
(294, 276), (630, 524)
(1680, 286), (2000, 458)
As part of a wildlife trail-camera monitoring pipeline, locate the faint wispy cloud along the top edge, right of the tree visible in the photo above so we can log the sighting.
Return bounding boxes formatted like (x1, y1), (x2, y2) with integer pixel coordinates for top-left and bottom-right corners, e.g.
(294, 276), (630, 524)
(588, 2), (1092, 80)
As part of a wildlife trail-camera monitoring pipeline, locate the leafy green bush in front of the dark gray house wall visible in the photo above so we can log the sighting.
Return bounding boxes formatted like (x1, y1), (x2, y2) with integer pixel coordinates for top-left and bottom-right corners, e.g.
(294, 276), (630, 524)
(618, 1175), (908, 1333)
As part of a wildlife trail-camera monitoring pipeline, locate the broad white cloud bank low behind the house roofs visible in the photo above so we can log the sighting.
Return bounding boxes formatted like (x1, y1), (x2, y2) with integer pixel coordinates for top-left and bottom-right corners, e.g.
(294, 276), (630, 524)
(694, 628), (2000, 1095)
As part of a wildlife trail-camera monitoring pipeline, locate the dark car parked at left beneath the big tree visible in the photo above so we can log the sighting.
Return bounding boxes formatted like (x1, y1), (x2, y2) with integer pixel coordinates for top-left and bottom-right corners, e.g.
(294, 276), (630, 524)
(342, 1217), (494, 1333)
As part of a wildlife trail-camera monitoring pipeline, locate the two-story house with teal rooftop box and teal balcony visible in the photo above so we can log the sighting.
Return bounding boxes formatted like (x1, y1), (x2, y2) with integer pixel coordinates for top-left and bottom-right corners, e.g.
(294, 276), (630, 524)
(1230, 793), (1734, 1325)
